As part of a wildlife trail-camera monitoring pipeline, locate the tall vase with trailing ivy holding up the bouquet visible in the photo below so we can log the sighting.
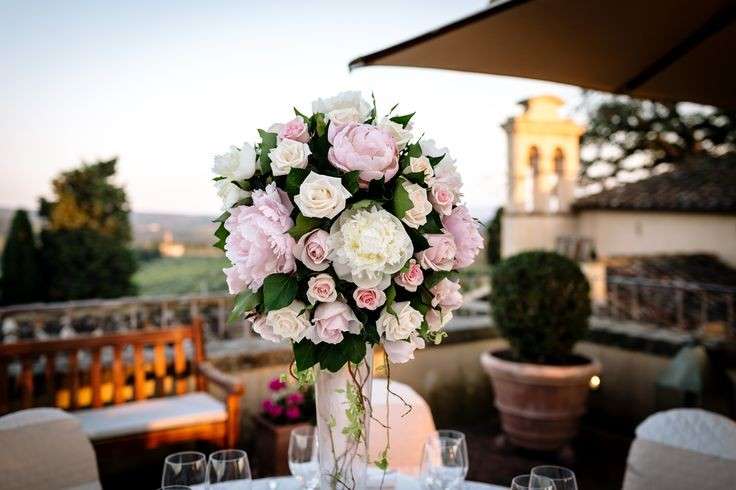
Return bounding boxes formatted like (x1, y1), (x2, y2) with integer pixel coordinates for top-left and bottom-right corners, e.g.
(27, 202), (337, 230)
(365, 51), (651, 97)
(315, 346), (373, 490)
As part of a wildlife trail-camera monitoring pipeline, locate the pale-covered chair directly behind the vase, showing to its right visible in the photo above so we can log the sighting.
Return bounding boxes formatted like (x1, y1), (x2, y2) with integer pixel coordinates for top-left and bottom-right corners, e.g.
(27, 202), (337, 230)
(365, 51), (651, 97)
(368, 379), (435, 475)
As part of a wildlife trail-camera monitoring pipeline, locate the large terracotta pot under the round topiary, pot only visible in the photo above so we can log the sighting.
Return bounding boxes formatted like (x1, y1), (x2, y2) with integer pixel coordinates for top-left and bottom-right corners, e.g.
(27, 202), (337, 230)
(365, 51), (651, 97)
(480, 351), (601, 450)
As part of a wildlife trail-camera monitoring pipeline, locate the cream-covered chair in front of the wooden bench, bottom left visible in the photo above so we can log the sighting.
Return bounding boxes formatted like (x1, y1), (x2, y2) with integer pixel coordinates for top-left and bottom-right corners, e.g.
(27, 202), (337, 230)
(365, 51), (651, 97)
(0, 408), (102, 490)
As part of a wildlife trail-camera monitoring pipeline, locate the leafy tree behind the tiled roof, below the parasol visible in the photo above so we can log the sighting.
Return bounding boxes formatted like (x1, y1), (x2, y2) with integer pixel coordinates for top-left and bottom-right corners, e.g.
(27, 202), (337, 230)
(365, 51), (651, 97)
(581, 96), (736, 184)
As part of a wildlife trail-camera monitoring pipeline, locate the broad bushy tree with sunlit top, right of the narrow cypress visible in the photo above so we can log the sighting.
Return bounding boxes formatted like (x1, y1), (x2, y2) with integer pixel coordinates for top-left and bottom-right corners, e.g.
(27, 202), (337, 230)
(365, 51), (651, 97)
(39, 159), (137, 301)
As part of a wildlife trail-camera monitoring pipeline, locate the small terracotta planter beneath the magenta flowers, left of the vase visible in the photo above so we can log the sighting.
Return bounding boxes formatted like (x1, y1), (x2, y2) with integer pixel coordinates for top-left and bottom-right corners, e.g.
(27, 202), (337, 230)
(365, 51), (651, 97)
(255, 415), (311, 476)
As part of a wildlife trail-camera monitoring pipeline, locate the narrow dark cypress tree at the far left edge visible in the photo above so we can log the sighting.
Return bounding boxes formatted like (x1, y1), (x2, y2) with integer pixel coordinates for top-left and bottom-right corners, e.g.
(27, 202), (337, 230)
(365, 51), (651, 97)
(0, 209), (41, 305)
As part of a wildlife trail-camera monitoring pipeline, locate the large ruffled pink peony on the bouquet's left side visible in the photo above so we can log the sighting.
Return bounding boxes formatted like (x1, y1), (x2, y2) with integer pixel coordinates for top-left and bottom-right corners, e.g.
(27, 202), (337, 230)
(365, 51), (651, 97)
(223, 184), (296, 294)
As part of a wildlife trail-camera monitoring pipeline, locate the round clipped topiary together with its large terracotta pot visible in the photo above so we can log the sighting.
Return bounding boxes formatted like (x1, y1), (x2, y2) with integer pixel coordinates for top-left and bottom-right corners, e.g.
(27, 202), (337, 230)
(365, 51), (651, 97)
(481, 251), (600, 450)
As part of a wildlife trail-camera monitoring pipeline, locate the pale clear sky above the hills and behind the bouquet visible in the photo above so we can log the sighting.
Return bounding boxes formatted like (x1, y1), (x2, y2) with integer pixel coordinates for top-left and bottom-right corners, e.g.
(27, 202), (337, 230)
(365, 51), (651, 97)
(0, 0), (580, 219)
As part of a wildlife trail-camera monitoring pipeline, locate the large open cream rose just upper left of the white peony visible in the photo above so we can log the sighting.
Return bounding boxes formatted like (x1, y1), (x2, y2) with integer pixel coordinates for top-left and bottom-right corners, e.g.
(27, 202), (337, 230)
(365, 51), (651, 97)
(294, 172), (351, 219)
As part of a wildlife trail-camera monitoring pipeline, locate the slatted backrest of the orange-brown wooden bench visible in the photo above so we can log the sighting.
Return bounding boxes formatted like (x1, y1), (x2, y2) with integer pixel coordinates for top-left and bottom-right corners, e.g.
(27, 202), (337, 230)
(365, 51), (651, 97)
(0, 319), (205, 414)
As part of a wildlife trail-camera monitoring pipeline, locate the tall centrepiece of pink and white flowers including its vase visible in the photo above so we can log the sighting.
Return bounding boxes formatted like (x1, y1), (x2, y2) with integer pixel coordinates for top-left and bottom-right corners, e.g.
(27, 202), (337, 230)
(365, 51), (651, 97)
(214, 92), (483, 489)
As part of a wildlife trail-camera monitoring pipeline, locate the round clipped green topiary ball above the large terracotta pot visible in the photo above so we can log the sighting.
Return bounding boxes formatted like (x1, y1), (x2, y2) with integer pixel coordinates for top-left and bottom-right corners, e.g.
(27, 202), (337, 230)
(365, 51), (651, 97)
(490, 251), (590, 364)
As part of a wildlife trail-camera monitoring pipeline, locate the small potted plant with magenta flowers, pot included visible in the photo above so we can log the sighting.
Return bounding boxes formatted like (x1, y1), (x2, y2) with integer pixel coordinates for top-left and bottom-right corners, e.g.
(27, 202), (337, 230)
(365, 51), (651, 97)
(255, 378), (314, 475)
